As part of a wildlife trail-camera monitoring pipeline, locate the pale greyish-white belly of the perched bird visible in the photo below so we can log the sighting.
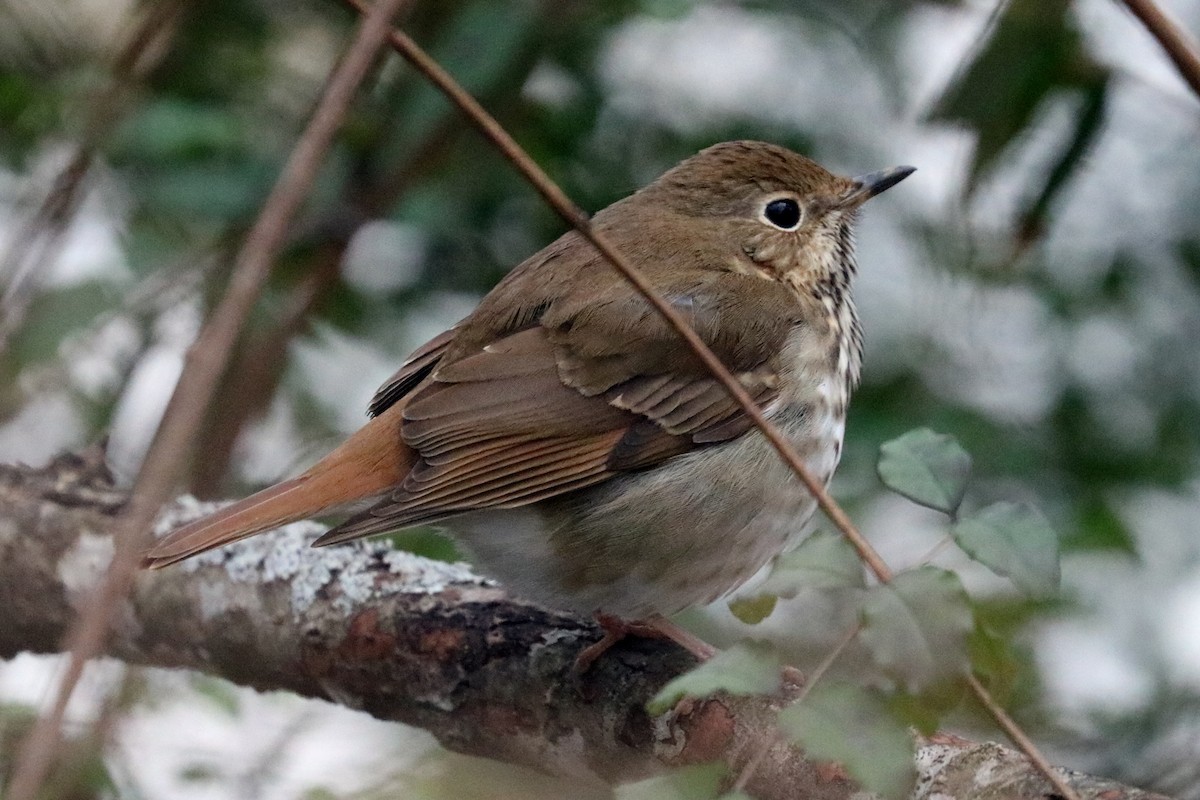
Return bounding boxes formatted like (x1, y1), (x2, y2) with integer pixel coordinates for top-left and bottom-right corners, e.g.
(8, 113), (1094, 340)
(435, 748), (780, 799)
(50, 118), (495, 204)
(448, 395), (845, 619)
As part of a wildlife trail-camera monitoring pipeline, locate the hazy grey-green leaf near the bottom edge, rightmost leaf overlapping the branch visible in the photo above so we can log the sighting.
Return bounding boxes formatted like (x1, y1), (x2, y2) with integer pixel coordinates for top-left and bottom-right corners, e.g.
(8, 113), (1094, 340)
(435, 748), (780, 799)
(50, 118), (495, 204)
(779, 685), (917, 798)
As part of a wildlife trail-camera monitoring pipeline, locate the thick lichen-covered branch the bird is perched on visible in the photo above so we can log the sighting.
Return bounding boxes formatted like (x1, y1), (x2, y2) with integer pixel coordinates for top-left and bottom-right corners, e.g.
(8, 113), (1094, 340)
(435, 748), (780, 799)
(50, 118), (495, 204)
(0, 453), (1153, 800)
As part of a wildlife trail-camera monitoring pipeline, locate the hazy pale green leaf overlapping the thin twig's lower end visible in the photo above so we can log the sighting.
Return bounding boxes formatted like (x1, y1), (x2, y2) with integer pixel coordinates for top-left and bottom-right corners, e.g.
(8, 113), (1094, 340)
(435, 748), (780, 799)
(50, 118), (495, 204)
(859, 566), (973, 692)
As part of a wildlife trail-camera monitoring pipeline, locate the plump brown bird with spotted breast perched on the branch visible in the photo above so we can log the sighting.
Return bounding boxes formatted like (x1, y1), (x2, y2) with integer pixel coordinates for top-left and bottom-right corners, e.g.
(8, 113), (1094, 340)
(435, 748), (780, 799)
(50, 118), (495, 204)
(146, 142), (913, 655)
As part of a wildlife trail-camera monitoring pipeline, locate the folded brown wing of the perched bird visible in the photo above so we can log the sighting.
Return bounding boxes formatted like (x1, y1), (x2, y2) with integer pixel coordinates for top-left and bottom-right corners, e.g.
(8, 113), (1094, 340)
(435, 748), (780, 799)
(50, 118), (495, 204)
(317, 273), (797, 545)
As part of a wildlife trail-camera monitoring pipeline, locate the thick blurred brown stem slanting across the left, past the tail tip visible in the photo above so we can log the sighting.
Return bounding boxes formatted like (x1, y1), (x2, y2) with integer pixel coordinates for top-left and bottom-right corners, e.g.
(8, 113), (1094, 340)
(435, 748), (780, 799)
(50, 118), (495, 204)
(7, 0), (408, 800)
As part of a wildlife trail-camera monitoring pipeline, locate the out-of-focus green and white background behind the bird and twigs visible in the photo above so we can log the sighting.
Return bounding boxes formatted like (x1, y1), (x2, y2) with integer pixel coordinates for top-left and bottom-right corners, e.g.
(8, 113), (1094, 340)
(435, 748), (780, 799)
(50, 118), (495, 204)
(0, 0), (1200, 800)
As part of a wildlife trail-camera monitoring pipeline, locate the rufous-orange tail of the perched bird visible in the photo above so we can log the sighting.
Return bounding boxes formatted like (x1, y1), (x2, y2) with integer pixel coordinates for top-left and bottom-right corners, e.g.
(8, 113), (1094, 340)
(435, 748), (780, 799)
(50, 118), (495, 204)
(143, 403), (416, 569)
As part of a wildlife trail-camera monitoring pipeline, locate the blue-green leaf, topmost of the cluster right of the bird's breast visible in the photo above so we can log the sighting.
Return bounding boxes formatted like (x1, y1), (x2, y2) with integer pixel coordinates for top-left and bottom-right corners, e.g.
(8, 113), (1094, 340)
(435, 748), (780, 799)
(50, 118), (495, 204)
(878, 428), (971, 513)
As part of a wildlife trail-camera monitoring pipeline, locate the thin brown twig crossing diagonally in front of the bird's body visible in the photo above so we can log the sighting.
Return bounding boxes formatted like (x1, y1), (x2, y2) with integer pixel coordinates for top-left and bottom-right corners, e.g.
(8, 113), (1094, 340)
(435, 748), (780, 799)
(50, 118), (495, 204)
(352, 10), (1079, 800)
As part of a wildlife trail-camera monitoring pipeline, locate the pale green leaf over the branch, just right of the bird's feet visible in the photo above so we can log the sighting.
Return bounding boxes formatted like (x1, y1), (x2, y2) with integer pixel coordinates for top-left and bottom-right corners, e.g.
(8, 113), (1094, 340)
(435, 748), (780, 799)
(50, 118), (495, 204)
(646, 642), (784, 716)
